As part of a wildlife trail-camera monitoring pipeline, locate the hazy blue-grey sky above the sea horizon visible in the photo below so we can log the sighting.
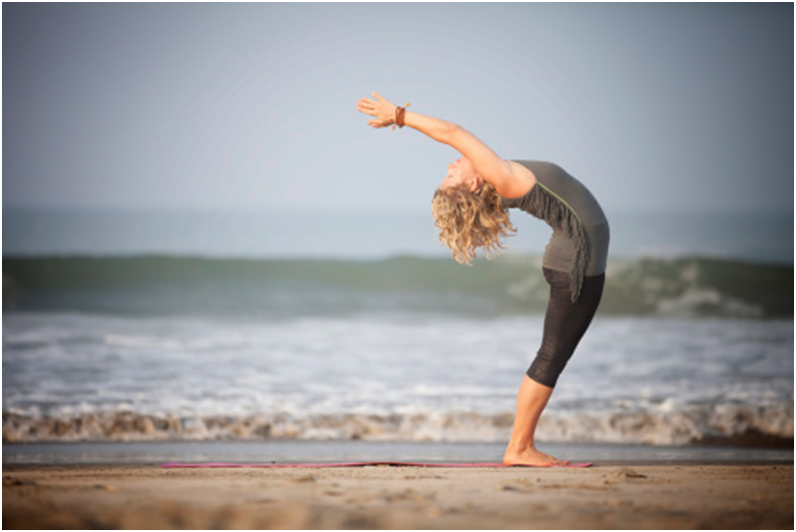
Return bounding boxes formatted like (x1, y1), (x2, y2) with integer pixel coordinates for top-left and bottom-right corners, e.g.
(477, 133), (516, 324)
(2, 3), (794, 212)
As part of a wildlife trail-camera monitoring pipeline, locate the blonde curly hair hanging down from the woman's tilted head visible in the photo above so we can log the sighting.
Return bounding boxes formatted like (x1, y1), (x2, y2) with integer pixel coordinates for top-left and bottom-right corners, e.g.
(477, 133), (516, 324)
(431, 181), (517, 264)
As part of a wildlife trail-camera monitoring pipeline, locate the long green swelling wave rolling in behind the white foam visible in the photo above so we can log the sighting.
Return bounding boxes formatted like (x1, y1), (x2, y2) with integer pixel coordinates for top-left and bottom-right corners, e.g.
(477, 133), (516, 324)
(2, 255), (794, 318)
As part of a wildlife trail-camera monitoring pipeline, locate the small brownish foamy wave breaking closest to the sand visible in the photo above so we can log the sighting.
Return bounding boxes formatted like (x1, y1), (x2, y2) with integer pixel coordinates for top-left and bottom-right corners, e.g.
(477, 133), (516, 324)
(3, 404), (793, 448)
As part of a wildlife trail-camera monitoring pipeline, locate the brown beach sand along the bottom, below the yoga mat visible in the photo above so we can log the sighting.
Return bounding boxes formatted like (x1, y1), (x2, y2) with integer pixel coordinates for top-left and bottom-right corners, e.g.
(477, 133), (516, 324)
(3, 463), (794, 530)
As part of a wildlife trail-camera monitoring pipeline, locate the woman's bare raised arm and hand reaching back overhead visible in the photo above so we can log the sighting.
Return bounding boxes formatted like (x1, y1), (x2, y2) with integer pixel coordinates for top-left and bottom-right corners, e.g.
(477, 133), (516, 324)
(357, 92), (536, 198)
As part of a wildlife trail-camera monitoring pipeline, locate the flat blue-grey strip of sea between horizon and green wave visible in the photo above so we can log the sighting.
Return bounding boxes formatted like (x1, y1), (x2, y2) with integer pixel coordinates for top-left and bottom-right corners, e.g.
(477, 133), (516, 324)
(2, 206), (794, 265)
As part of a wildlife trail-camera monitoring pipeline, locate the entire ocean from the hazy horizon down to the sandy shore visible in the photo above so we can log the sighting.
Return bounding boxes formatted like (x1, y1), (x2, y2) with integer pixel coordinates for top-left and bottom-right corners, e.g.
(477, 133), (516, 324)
(2, 209), (794, 460)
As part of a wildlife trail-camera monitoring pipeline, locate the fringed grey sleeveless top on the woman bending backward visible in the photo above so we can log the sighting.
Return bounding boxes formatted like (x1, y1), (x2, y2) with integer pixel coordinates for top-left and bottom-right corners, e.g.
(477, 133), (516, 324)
(502, 161), (610, 303)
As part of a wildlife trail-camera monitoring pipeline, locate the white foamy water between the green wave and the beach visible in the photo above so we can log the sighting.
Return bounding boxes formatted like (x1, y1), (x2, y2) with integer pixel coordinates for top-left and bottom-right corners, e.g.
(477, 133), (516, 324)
(3, 313), (794, 445)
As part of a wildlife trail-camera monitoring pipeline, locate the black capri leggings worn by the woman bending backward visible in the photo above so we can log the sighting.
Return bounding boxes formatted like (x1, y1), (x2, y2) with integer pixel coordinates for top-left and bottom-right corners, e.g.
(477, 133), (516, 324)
(527, 268), (605, 388)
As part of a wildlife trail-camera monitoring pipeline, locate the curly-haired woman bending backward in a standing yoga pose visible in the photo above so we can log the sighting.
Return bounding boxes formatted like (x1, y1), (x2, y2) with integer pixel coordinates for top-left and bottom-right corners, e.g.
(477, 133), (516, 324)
(357, 92), (609, 466)
